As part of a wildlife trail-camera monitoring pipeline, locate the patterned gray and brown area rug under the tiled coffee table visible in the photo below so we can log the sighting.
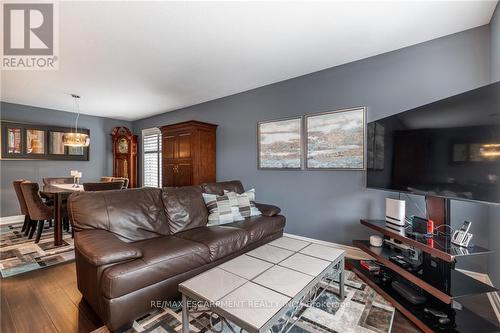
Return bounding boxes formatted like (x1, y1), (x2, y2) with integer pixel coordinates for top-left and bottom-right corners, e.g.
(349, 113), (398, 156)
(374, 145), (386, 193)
(92, 271), (395, 333)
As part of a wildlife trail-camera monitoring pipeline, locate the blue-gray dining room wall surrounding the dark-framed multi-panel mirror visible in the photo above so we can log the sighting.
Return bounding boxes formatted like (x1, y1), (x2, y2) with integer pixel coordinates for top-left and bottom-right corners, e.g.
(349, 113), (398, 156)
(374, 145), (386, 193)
(0, 102), (132, 217)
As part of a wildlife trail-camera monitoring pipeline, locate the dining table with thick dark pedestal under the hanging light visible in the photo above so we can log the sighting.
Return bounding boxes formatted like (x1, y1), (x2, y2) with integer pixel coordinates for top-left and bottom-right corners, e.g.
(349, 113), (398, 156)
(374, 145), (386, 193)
(40, 184), (83, 246)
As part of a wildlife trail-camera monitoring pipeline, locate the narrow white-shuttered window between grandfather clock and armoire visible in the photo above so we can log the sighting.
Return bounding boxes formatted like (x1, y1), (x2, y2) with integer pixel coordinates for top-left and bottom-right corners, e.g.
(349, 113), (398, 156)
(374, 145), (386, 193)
(142, 128), (161, 187)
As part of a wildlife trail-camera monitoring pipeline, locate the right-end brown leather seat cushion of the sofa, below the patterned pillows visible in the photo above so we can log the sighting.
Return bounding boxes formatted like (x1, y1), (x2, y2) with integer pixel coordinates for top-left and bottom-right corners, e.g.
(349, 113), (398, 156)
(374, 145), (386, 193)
(225, 215), (285, 244)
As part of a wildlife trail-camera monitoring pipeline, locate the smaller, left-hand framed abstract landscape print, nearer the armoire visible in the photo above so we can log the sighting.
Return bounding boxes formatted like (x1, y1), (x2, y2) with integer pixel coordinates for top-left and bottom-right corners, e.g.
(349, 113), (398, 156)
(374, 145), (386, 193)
(259, 118), (302, 169)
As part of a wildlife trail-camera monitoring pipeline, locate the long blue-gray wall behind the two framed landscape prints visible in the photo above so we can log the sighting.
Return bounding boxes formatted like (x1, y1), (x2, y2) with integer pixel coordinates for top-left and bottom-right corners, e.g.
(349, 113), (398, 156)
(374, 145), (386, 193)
(133, 26), (490, 249)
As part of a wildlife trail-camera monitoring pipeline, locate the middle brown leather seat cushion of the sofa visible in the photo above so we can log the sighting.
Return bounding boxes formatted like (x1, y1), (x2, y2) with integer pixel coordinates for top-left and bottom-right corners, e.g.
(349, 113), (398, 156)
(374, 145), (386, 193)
(175, 225), (249, 261)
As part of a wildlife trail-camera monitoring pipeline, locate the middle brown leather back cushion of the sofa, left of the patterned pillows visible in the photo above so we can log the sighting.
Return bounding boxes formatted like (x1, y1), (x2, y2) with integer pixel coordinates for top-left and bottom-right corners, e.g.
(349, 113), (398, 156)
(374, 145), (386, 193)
(162, 186), (208, 234)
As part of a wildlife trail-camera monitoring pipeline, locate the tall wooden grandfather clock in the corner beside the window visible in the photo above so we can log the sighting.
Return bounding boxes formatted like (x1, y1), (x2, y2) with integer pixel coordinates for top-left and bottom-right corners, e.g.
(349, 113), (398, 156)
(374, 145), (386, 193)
(111, 127), (137, 187)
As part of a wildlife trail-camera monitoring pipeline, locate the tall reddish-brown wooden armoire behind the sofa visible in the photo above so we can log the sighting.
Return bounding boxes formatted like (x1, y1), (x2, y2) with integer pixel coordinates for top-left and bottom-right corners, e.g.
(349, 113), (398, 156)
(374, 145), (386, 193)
(160, 120), (217, 187)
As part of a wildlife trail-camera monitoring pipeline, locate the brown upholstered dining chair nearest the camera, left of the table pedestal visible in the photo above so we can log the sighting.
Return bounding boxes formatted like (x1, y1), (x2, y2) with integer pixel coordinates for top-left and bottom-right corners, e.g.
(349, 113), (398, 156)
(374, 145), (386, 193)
(21, 181), (54, 243)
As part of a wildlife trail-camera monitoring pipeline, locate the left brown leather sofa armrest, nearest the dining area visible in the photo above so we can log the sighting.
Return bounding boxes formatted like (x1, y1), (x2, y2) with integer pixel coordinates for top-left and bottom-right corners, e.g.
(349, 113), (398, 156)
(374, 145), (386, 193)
(75, 229), (142, 266)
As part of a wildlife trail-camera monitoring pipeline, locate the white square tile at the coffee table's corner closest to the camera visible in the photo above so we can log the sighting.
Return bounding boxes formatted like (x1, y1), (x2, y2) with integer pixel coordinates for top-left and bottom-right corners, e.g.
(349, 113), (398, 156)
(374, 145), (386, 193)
(219, 282), (290, 329)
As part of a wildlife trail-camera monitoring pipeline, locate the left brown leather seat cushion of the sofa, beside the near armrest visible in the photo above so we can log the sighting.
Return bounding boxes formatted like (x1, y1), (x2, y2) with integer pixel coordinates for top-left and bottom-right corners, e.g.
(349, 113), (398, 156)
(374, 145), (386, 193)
(101, 236), (210, 298)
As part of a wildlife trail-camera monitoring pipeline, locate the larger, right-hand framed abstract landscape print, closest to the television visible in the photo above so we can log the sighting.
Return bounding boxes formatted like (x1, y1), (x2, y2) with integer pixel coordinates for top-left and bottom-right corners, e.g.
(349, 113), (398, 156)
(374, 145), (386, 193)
(307, 109), (365, 169)
